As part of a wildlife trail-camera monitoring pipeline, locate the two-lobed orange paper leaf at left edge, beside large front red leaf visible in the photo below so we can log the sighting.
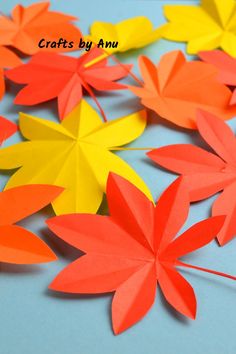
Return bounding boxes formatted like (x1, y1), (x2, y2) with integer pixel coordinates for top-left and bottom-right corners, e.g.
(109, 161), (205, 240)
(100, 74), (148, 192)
(0, 185), (62, 264)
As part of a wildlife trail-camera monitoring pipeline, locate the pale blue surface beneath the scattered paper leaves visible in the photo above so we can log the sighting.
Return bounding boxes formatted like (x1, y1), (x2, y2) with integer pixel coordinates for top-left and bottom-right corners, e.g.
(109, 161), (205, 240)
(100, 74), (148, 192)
(0, 0), (236, 354)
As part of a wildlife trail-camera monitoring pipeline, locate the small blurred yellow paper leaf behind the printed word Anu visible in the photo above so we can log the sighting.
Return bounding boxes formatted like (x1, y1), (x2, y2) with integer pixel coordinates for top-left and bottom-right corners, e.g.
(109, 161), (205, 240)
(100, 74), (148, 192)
(86, 16), (165, 54)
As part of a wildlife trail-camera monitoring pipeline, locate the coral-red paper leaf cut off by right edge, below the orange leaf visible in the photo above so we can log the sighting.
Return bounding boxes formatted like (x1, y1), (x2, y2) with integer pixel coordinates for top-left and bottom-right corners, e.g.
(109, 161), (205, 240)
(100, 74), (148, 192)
(147, 111), (236, 245)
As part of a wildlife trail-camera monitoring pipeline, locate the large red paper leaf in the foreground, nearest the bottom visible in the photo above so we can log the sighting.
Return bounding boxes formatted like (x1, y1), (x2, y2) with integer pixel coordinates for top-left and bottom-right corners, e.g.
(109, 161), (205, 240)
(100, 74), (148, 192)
(47, 174), (225, 333)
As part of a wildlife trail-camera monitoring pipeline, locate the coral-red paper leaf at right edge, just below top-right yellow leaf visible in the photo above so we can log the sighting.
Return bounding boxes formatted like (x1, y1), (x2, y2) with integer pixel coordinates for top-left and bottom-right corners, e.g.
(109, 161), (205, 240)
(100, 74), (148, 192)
(198, 50), (236, 105)
